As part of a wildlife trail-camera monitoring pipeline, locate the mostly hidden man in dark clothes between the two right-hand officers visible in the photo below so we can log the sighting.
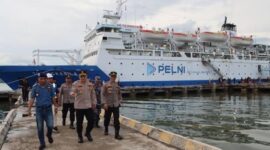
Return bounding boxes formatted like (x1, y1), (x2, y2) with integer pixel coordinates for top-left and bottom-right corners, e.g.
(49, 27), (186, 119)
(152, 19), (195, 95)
(94, 76), (102, 128)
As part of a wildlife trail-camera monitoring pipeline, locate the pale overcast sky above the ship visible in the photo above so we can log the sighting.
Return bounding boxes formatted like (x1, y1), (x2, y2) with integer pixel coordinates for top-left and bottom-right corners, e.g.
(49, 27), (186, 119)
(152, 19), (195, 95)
(0, 0), (270, 65)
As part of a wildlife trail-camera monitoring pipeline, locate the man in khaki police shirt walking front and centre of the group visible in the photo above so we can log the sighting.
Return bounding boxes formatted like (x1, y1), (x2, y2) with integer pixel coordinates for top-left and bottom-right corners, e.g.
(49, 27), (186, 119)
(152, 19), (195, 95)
(71, 71), (97, 143)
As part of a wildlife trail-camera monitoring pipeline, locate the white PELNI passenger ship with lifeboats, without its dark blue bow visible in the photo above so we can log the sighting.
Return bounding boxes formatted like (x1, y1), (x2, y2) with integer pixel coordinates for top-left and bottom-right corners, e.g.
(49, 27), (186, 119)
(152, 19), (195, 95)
(82, 0), (270, 86)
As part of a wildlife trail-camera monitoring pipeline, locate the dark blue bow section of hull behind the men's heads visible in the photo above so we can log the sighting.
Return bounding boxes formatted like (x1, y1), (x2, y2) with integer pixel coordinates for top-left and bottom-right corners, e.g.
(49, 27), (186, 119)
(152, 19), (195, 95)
(0, 66), (109, 90)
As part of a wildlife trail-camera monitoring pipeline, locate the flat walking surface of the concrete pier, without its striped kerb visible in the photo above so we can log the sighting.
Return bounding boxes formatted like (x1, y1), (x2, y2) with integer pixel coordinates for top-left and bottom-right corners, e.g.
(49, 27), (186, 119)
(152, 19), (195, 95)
(2, 107), (174, 150)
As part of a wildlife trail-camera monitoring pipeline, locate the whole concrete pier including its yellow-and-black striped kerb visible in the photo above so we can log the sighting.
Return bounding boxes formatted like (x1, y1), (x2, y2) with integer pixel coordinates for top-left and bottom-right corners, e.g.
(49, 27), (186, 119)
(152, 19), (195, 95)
(1, 106), (220, 150)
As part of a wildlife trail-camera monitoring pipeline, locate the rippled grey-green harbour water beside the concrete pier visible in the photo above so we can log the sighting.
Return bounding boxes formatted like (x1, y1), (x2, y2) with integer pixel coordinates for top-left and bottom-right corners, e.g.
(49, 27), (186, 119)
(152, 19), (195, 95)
(0, 93), (270, 150)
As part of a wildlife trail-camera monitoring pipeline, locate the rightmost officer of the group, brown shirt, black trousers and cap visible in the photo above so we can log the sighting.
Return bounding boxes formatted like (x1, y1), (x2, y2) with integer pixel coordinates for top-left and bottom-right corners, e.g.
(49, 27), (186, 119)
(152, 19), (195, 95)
(101, 71), (123, 140)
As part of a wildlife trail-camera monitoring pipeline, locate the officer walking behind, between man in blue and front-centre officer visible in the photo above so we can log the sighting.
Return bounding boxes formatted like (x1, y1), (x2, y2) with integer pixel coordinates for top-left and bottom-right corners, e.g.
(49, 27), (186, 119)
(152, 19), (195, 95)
(59, 75), (75, 129)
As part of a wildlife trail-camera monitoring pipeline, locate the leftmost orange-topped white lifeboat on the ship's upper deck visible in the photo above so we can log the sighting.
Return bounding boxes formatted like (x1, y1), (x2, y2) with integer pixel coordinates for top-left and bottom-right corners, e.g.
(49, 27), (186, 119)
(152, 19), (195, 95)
(140, 30), (169, 41)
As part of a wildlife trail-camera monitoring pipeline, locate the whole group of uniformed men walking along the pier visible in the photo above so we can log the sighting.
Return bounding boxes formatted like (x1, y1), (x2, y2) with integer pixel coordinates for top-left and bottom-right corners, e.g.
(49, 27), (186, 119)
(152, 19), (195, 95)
(28, 71), (123, 149)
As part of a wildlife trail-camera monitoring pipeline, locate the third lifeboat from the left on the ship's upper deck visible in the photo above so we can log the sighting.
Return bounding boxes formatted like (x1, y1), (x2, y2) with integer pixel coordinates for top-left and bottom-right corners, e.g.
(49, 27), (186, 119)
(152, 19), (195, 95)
(200, 32), (228, 42)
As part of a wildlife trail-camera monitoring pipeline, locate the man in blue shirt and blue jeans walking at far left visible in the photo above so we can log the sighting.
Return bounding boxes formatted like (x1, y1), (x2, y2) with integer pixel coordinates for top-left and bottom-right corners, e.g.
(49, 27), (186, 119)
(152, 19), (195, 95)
(28, 73), (55, 150)
